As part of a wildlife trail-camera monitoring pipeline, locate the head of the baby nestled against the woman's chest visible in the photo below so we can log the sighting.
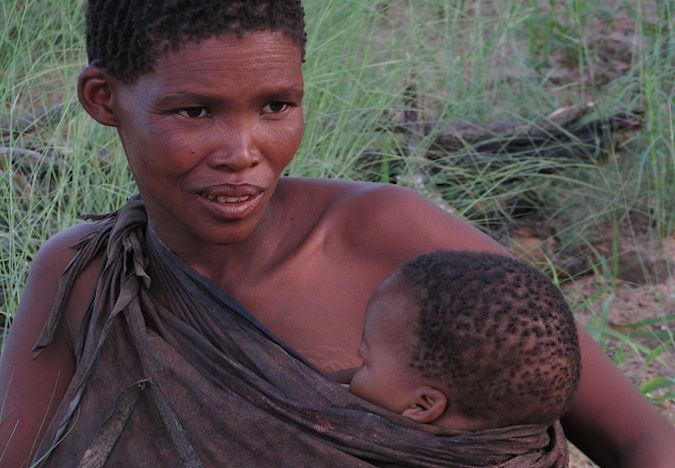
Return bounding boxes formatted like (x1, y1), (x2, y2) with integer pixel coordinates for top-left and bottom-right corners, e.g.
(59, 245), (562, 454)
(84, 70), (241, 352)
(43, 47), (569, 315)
(351, 252), (580, 430)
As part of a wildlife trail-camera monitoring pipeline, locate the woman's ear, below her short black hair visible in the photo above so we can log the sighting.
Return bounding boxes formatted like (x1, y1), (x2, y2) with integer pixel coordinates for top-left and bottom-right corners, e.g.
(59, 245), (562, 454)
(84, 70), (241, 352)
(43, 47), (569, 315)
(77, 65), (117, 127)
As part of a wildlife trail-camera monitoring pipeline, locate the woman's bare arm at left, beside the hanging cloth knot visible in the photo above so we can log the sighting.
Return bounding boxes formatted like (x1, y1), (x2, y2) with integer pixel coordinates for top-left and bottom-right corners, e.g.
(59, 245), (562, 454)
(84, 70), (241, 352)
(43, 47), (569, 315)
(0, 225), (97, 467)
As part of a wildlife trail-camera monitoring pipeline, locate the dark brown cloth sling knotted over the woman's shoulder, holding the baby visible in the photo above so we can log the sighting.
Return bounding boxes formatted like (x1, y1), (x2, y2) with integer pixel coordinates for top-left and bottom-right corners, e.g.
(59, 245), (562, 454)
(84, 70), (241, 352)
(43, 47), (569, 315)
(33, 199), (567, 467)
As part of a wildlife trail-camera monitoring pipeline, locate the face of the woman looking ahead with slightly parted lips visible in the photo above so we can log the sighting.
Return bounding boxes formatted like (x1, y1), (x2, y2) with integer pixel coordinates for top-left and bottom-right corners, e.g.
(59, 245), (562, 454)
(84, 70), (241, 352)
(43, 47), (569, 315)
(113, 32), (303, 252)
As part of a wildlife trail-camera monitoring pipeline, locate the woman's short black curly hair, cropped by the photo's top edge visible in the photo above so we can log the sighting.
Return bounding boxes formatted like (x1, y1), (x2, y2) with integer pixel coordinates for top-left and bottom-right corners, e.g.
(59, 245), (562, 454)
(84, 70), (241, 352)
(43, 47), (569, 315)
(86, 0), (307, 83)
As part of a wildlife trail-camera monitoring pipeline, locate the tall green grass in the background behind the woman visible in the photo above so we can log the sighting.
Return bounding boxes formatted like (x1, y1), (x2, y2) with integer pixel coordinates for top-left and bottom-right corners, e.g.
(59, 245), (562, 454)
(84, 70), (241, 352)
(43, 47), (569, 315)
(0, 0), (675, 399)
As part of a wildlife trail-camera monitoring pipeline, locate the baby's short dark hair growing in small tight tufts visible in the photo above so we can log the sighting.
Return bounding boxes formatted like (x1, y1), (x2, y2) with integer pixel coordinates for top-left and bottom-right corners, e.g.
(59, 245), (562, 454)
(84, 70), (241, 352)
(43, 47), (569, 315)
(401, 251), (580, 427)
